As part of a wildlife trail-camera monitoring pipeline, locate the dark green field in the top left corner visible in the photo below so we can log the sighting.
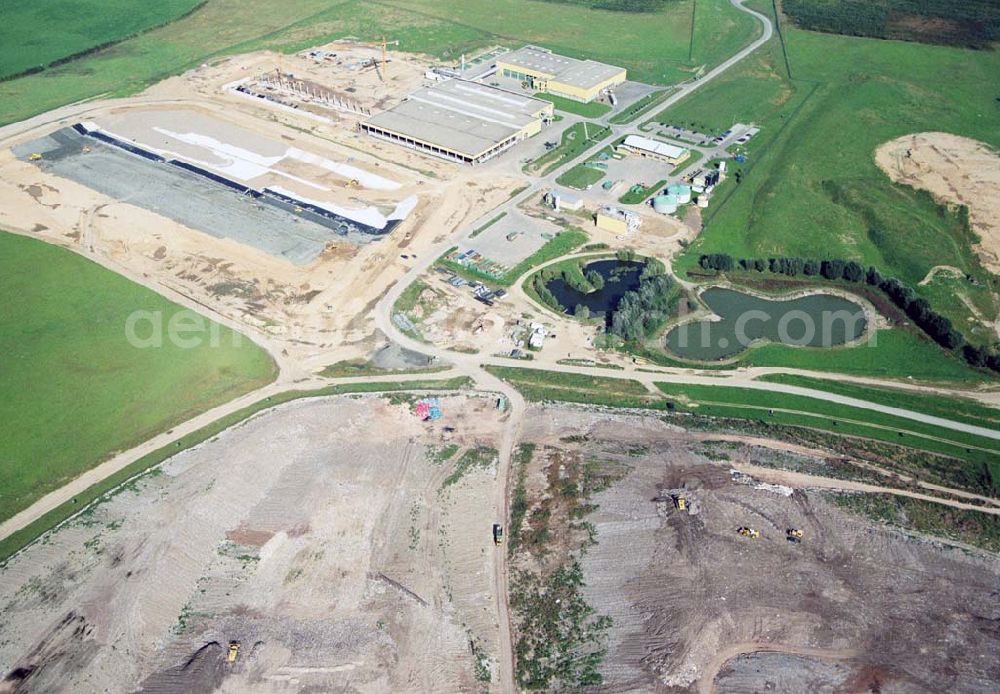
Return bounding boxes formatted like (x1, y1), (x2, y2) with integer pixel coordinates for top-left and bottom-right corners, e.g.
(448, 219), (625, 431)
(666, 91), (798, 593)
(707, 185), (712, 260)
(0, 0), (202, 79)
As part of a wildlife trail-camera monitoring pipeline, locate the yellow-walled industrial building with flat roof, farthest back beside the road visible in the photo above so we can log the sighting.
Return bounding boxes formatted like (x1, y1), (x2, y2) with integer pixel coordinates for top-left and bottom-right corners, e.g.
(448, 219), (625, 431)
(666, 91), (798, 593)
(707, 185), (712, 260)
(496, 46), (626, 103)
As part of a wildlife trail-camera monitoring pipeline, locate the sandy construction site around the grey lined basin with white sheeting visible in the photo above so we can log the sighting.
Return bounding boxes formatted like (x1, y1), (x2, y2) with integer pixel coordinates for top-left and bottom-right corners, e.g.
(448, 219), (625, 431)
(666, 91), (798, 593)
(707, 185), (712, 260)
(0, 42), (532, 368)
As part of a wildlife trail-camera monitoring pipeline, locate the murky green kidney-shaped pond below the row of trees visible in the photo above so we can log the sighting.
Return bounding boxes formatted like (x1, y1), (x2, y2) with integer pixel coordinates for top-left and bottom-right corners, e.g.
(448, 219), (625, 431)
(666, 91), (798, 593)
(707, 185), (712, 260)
(666, 287), (867, 361)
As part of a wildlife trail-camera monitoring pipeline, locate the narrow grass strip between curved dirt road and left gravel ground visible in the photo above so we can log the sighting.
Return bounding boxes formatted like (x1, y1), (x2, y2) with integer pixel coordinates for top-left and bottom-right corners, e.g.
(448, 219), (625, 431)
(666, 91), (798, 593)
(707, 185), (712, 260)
(0, 376), (471, 563)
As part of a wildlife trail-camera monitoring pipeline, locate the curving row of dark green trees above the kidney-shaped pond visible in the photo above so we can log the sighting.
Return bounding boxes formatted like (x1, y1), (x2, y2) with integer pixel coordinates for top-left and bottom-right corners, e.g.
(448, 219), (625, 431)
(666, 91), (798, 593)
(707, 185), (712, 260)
(698, 253), (1000, 371)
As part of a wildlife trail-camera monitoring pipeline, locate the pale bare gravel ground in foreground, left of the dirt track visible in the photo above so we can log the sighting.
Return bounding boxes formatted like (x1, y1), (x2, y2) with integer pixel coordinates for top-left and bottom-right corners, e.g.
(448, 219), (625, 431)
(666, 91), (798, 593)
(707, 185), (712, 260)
(0, 397), (498, 692)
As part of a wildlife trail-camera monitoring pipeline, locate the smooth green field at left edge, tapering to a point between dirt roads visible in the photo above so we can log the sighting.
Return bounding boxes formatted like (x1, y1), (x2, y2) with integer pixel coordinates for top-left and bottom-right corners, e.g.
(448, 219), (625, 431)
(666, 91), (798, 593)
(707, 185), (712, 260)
(0, 233), (275, 519)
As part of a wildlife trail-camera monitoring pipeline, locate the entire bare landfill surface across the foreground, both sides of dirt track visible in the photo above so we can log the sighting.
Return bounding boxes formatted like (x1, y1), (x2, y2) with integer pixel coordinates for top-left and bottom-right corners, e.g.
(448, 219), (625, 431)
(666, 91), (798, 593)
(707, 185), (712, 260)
(0, 395), (1000, 692)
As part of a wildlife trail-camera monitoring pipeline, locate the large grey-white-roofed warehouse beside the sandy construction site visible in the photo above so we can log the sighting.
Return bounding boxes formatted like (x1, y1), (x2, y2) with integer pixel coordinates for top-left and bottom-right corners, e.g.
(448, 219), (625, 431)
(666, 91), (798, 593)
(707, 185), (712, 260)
(359, 79), (553, 164)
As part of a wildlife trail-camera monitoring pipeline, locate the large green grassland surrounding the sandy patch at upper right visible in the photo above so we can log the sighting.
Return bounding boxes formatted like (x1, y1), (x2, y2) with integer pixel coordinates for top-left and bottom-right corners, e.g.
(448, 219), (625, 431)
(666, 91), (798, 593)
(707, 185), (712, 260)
(658, 3), (1000, 373)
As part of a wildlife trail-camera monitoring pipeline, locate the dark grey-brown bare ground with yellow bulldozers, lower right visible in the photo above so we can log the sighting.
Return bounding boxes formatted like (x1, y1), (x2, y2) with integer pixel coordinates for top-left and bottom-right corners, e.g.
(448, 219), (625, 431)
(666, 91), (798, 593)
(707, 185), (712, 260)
(525, 408), (1000, 692)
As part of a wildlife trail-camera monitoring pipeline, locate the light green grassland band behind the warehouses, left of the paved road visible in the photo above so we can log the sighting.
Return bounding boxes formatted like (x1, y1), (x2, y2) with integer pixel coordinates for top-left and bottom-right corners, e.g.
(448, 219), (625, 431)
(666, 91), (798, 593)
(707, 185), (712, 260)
(0, 0), (759, 125)
